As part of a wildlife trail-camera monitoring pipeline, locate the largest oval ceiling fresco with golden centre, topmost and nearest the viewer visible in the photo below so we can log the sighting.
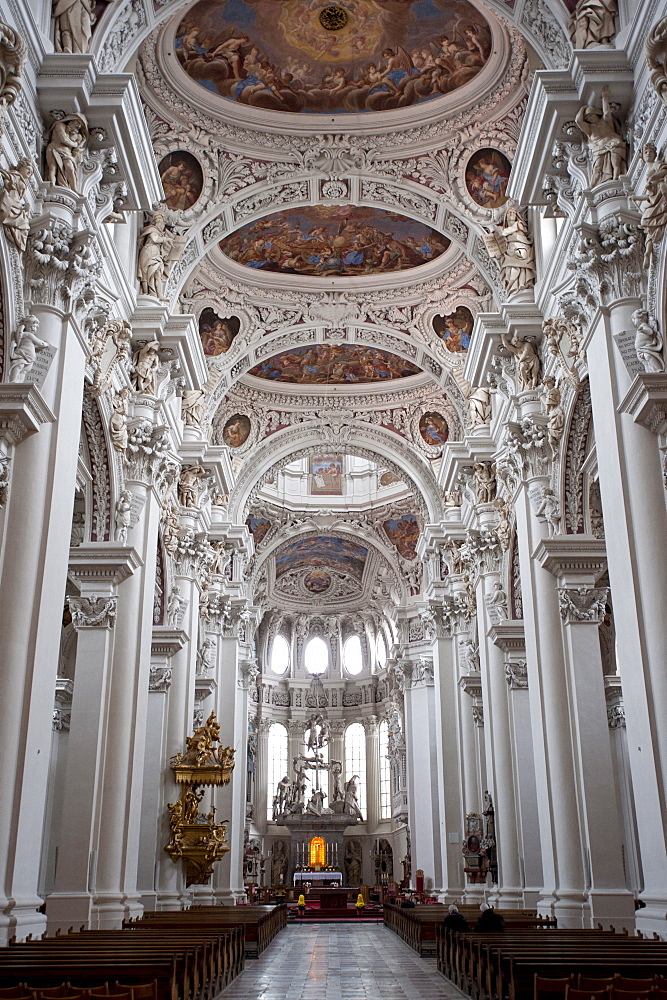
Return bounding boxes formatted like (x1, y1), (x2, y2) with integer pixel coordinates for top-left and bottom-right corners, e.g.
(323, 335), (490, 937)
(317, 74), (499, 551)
(176, 0), (491, 114)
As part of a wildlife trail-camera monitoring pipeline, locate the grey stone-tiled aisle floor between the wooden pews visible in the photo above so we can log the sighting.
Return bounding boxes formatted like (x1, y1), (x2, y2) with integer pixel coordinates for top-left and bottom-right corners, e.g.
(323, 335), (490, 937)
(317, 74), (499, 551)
(222, 924), (463, 1000)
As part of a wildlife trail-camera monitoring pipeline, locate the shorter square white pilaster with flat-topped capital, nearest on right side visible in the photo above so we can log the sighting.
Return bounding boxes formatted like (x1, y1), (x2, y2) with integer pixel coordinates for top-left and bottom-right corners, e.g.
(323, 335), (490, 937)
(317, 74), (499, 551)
(535, 535), (634, 930)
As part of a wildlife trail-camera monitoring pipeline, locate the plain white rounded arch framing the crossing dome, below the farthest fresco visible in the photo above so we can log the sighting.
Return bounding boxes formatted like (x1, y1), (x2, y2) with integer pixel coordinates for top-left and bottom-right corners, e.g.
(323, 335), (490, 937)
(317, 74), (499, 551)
(228, 420), (443, 524)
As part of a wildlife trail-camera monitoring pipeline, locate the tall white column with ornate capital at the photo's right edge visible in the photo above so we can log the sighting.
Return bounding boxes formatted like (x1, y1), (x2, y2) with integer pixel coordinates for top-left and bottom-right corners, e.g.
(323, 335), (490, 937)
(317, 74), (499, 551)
(580, 197), (667, 936)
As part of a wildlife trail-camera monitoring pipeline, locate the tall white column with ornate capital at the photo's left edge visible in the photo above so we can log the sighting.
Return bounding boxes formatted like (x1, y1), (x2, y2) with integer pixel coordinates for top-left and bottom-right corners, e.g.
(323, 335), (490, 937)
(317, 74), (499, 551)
(0, 199), (95, 944)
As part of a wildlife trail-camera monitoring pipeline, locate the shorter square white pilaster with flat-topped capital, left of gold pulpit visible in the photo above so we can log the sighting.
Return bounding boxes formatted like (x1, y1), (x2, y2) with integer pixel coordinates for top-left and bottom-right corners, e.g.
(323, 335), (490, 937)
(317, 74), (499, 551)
(46, 542), (139, 934)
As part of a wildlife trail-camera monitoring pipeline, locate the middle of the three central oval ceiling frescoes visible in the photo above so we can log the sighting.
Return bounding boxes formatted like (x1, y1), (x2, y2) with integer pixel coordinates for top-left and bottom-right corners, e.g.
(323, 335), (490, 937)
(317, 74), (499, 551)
(219, 205), (451, 278)
